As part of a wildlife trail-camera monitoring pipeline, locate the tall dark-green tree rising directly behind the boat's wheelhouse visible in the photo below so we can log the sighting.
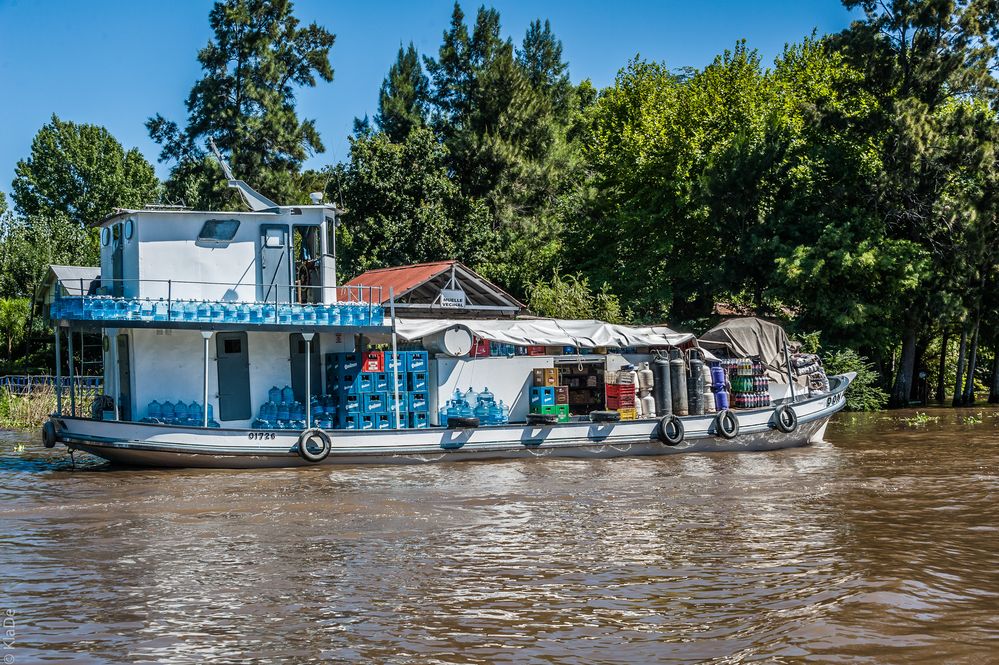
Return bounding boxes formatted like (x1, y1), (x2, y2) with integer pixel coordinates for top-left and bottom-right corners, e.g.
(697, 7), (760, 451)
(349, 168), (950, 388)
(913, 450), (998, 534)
(146, 0), (335, 209)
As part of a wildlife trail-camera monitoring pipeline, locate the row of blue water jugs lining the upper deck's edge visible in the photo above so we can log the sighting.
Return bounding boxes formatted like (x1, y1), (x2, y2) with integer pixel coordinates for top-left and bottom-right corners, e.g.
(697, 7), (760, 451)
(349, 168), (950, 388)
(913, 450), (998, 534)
(51, 296), (385, 326)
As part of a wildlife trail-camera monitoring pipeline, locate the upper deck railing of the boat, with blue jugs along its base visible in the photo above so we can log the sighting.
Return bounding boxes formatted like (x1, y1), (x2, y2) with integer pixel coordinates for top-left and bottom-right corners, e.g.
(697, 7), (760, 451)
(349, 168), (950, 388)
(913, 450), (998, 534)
(50, 278), (385, 327)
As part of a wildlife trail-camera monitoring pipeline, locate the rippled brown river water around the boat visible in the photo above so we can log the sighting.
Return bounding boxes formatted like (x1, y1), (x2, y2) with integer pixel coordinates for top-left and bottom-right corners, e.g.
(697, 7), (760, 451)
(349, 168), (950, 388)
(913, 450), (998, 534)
(0, 408), (999, 663)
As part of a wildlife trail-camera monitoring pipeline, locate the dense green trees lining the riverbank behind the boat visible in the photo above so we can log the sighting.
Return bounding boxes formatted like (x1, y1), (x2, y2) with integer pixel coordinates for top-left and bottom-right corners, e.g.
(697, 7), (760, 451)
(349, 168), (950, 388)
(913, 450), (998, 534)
(0, 0), (999, 409)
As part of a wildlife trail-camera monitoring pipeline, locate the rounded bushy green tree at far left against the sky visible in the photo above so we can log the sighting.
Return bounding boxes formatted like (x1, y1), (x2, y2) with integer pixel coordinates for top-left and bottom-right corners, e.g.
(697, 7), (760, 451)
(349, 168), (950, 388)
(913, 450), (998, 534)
(11, 115), (159, 226)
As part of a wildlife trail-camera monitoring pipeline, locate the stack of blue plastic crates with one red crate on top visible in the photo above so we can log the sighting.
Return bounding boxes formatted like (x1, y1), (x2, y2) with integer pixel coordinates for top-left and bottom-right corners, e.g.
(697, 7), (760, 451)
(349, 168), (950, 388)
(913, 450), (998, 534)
(328, 351), (430, 430)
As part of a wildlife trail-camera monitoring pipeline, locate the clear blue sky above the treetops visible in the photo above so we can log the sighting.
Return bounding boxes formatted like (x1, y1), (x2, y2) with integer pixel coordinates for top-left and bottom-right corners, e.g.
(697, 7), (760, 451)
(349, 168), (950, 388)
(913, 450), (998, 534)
(0, 0), (851, 193)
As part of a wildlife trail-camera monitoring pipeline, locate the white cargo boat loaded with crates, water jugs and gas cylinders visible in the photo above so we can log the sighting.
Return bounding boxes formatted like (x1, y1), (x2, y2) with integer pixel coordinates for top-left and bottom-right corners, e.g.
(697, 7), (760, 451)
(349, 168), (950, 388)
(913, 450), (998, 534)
(36, 177), (854, 468)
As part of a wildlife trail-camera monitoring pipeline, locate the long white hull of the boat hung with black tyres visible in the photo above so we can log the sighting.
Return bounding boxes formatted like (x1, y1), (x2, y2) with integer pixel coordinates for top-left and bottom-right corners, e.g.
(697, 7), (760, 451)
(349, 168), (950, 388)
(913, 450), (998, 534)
(51, 375), (853, 468)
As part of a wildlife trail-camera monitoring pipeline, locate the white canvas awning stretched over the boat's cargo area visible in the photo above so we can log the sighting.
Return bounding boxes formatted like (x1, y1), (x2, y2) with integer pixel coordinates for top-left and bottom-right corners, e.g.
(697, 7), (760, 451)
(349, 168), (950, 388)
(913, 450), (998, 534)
(396, 319), (694, 349)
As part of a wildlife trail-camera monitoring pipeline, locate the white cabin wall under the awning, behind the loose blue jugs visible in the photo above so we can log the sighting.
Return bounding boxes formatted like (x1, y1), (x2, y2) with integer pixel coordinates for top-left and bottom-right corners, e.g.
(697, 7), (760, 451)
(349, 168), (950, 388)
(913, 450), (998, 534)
(430, 356), (555, 425)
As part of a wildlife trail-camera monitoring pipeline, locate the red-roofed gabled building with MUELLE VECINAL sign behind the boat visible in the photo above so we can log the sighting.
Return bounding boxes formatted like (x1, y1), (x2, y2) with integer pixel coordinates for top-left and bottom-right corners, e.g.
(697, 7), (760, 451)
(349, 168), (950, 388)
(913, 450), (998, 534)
(343, 261), (524, 318)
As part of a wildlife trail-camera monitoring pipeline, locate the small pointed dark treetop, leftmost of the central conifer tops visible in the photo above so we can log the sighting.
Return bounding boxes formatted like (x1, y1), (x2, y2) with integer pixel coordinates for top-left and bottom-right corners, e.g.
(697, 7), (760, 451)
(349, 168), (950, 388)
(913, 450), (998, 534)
(375, 42), (430, 143)
